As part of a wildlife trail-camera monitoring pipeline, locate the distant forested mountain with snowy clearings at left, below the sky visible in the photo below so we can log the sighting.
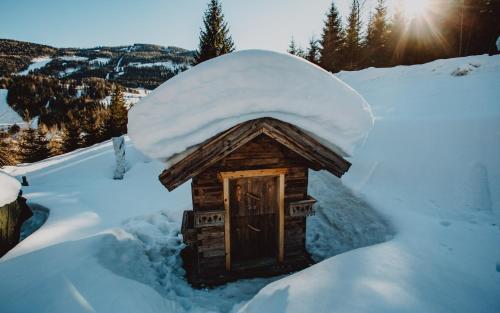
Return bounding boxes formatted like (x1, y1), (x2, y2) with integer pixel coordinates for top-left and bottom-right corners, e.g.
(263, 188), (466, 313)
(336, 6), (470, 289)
(0, 39), (194, 89)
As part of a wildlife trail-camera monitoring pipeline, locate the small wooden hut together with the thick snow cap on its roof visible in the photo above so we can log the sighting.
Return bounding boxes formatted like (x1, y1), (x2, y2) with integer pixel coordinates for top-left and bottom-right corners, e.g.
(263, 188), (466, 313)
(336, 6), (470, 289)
(128, 50), (373, 285)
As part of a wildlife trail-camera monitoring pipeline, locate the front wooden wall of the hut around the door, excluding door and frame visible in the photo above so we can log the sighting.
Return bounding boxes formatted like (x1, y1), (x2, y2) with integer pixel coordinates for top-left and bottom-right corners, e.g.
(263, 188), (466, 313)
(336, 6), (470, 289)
(191, 135), (309, 276)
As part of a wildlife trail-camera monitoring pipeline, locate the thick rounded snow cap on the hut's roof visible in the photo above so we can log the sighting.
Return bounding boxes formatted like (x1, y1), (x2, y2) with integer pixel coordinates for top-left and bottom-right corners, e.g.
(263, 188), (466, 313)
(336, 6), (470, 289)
(128, 50), (373, 167)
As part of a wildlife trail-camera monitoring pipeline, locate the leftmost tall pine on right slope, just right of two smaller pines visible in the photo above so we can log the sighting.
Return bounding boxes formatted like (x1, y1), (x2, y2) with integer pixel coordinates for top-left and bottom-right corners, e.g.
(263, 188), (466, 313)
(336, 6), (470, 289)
(319, 2), (345, 72)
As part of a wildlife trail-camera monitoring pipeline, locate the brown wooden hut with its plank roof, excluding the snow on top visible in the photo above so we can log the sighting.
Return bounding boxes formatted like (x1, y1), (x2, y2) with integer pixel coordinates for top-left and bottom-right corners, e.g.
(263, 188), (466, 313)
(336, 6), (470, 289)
(160, 118), (351, 285)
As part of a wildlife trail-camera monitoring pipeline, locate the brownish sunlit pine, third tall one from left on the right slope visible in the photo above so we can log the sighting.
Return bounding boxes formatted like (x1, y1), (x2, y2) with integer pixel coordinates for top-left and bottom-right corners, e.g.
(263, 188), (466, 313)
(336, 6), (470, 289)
(364, 0), (390, 67)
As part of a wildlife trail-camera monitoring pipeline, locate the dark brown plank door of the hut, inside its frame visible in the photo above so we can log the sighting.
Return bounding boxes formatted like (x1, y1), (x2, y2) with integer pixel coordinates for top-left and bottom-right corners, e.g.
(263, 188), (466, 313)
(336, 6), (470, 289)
(229, 176), (279, 265)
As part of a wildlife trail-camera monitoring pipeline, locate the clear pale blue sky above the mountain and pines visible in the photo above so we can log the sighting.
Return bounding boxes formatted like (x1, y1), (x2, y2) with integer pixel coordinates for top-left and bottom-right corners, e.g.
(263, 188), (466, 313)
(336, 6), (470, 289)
(0, 0), (394, 51)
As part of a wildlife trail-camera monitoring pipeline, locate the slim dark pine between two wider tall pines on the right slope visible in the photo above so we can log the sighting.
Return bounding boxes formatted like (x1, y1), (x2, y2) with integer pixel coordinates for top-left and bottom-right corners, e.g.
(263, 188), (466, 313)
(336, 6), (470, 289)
(345, 0), (361, 70)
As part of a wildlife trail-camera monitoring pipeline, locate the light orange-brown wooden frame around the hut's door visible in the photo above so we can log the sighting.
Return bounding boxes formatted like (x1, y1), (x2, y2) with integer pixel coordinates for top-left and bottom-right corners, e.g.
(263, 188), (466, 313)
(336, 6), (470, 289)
(219, 168), (288, 271)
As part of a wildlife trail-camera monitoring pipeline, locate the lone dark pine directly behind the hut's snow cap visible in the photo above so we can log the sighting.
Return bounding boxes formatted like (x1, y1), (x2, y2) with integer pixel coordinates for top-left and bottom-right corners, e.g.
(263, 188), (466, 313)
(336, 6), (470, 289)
(194, 0), (234, 64)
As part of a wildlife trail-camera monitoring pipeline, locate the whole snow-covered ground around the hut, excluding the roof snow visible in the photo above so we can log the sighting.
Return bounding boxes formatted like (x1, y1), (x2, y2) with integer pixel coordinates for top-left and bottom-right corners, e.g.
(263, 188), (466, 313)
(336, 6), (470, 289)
(0, 56), (500, 313)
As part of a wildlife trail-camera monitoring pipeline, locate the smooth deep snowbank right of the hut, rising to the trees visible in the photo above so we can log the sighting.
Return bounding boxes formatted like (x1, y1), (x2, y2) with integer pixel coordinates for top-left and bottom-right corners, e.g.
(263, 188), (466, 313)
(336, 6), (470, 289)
(241, 56), (500, 312)
